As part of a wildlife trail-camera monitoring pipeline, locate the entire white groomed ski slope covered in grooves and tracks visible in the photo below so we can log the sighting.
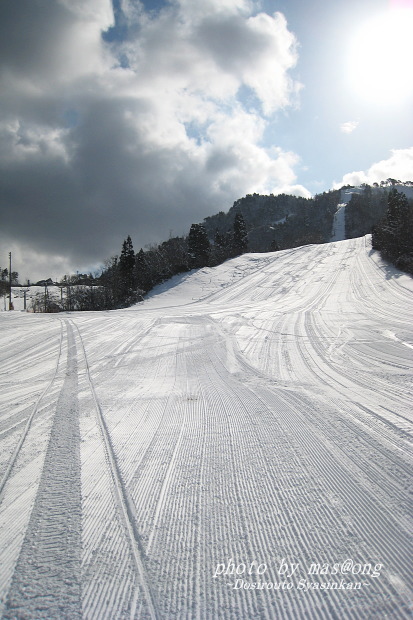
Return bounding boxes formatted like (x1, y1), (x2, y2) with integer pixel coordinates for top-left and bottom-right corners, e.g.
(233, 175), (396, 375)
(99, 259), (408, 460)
(0, 237), (413, 620)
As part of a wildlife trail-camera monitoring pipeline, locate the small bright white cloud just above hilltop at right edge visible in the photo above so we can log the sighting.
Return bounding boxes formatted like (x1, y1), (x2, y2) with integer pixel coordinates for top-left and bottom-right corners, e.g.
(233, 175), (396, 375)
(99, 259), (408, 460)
(334, 147), (413, 188)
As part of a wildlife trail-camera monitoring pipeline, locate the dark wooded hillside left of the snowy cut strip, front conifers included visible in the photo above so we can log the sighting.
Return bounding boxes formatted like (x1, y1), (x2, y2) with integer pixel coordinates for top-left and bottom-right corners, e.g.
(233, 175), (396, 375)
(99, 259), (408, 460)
(80, 190), (339, 310)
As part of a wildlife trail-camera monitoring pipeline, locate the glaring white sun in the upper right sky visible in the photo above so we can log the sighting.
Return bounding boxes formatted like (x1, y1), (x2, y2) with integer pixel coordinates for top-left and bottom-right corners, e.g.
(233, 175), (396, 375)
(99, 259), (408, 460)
(348, 8), (413, 105)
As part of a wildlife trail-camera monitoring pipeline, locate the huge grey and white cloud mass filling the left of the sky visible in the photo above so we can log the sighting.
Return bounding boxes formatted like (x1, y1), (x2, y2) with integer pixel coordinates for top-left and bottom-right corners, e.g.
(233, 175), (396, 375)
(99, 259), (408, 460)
(0, 0), (307, 277)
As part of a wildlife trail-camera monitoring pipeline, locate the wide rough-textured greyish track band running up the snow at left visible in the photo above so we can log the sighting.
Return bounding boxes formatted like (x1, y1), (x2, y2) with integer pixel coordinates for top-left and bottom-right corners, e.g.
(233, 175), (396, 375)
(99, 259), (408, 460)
(4, 326), (81, 619)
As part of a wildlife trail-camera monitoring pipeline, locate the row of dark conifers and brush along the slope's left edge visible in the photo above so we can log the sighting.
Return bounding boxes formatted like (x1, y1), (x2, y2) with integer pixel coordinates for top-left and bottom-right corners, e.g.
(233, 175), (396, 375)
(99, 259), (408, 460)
(31, 213), (248, 312)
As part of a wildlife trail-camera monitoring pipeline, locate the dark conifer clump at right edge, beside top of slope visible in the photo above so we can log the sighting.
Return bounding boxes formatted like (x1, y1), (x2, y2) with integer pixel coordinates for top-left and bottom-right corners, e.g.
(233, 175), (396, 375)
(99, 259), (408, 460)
(372, 188), (413, 275)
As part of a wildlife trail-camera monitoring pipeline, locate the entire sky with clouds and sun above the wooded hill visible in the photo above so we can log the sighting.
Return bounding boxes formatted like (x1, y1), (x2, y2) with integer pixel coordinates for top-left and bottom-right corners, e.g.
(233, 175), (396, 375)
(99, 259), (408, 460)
(0, 0), (413, 282)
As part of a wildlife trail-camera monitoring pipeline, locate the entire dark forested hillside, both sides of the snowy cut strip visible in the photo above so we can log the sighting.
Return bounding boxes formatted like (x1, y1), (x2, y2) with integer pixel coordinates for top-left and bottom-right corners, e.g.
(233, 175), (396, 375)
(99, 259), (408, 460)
(5, 179), (413, 311)
